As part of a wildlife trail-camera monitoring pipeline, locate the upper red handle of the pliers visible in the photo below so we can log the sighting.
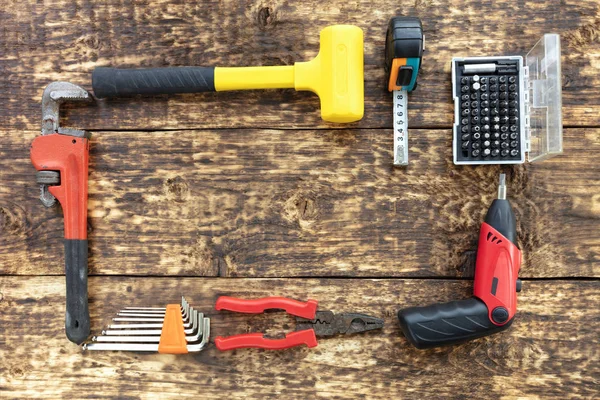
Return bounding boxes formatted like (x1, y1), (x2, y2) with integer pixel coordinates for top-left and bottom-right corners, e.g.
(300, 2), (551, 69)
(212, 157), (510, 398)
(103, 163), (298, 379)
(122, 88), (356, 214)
(215, 296), (317, 318)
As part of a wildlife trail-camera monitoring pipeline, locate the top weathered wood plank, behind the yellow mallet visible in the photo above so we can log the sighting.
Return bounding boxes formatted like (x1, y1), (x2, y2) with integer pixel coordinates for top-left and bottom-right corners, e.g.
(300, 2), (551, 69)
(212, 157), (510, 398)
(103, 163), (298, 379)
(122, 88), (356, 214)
(0, 0), (600, 130)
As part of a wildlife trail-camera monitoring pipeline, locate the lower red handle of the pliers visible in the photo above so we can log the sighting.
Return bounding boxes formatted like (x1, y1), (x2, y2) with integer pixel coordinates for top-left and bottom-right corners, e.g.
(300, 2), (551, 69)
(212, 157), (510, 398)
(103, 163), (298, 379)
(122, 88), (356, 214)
(215, 329), (317, 351)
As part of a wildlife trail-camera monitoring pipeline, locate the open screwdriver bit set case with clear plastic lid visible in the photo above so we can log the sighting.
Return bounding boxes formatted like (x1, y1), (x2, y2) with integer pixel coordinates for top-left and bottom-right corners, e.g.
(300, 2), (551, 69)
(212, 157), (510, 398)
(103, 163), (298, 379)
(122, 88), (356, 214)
(452, 34), (562, 164)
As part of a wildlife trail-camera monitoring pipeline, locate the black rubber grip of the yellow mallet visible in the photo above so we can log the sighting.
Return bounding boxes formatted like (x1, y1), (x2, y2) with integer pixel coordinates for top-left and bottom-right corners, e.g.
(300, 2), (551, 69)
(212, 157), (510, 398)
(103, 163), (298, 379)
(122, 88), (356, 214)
(92, 67), (215, 98)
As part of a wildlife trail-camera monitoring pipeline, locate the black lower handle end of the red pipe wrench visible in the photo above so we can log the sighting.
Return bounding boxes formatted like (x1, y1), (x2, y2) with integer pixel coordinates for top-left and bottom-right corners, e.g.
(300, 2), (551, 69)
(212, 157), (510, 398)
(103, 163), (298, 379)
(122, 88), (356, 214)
(65, 239), (90, 344)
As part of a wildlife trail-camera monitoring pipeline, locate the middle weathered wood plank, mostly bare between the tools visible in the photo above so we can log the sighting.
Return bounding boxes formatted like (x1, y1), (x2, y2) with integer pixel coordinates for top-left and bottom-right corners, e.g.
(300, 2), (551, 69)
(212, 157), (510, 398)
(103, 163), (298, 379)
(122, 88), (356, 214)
(0, 128), (600, 277)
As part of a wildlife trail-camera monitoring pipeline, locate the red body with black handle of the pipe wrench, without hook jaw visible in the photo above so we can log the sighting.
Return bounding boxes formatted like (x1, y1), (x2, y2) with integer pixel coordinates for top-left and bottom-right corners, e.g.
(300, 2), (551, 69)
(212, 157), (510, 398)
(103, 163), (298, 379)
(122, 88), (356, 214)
(31, 133), (90, 344)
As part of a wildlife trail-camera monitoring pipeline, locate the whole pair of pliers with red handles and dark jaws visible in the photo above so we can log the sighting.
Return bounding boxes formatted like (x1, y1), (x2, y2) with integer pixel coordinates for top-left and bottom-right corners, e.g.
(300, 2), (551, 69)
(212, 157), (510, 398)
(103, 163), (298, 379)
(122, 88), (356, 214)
(215, 296), (383, 351)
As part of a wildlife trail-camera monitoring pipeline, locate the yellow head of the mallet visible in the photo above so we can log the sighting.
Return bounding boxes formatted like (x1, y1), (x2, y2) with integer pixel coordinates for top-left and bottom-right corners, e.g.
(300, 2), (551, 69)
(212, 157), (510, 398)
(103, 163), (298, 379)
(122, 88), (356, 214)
(294, 25), (365, 122)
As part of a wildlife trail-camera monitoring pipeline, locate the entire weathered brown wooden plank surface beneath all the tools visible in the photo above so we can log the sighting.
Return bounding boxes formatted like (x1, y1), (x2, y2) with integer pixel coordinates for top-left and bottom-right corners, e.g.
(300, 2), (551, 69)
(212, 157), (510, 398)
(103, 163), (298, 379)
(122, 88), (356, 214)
(0, 0), (600, 399)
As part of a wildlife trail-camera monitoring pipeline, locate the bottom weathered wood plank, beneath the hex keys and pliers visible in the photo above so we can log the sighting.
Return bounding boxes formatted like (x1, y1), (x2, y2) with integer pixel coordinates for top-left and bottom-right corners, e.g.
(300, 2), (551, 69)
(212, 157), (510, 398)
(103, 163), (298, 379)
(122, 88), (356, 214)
(0, 277), (600, 399)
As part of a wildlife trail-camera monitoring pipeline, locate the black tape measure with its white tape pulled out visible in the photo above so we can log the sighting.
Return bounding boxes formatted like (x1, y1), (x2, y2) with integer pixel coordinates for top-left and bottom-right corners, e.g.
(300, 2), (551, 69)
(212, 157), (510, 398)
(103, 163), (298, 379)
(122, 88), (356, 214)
(385, 17), (425, 166)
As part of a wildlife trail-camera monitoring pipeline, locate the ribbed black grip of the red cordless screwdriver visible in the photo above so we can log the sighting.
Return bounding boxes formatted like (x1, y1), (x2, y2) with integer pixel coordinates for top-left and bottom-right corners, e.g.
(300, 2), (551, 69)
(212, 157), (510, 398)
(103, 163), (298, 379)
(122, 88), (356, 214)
(398, 297), (512, 349)
